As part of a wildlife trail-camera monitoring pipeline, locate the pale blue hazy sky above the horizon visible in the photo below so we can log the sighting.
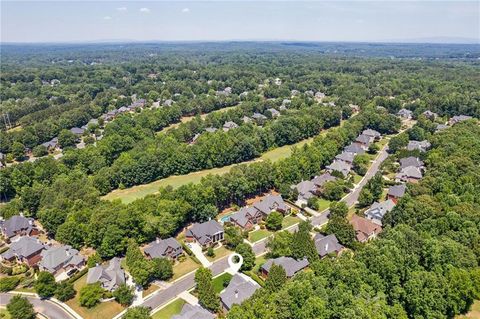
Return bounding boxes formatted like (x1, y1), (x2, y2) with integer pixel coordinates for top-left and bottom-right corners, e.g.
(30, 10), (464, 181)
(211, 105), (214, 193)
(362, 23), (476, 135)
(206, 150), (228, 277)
(0, 0), (480, 43)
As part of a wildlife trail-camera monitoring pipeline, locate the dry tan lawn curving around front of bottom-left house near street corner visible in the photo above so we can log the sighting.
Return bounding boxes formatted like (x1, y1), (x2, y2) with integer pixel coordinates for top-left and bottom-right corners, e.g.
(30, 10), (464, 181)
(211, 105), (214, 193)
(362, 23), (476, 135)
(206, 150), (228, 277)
(66, 274), (124, 319)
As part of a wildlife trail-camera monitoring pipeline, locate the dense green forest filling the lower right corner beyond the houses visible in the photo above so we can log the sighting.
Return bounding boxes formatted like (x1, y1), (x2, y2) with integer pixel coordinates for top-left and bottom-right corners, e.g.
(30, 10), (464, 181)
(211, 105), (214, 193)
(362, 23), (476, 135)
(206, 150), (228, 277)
(228, 123), (480, 319)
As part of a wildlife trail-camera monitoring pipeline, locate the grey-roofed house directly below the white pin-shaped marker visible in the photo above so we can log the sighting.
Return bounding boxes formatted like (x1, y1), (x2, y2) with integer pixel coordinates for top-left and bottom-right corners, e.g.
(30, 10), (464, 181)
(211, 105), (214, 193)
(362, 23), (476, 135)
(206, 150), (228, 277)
(220, 273), (260, 311)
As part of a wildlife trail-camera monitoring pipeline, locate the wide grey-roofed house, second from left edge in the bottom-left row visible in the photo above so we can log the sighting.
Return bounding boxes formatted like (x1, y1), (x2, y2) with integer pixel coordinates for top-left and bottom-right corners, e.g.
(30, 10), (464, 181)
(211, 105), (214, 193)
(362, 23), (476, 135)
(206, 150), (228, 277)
(38, 245), (85, 276)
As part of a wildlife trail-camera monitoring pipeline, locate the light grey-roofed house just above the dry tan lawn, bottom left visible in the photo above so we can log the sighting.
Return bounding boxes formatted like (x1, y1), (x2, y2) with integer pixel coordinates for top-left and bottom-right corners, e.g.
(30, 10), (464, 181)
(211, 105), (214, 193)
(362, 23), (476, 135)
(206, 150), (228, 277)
(87, 257), (125, 291)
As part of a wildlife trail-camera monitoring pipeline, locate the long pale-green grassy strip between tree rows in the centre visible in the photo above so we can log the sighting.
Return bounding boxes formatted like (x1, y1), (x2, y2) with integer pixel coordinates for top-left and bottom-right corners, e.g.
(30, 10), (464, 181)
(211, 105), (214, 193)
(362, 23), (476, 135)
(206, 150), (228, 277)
(102, 138), (313, 203)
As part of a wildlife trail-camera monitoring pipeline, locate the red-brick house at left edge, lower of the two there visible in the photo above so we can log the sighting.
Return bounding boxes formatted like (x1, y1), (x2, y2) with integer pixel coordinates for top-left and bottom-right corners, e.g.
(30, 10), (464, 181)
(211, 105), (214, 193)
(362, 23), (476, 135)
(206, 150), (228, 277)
(0, 236), (45, 267)
